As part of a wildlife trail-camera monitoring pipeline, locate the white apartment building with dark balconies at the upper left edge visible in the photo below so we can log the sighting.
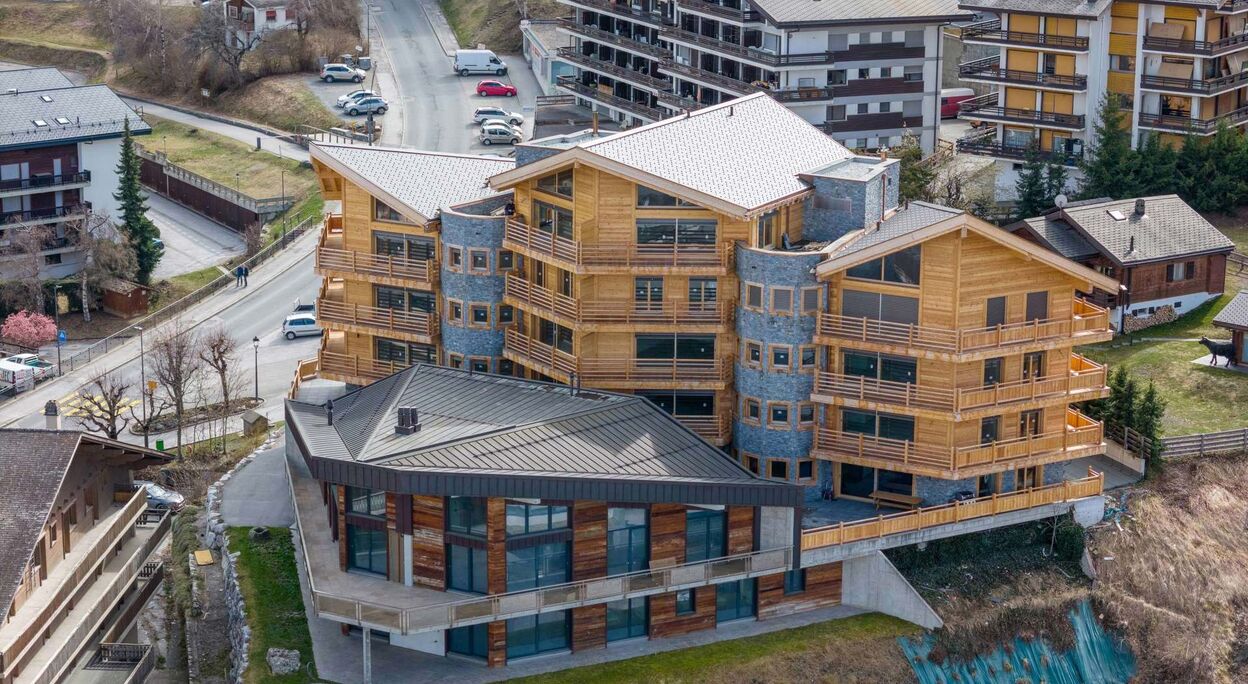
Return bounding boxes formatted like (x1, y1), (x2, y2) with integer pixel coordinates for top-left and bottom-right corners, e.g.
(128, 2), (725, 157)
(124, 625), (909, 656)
(0, 69), (151, 278)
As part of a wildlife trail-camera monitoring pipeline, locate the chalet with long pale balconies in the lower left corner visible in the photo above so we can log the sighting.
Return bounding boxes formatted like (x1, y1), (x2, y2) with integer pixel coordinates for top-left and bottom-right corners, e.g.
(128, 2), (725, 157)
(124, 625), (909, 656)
(0, 429), (172, 684)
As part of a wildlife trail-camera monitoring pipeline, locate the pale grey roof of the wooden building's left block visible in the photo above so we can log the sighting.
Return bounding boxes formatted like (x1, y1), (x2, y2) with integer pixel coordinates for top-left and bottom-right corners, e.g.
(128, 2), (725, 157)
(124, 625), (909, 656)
(311, 144), (515, 220)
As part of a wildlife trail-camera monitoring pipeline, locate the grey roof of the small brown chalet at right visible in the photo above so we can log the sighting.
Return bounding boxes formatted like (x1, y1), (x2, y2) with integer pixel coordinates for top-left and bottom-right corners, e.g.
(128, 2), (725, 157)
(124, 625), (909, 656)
(1048, 195), (1236, 266)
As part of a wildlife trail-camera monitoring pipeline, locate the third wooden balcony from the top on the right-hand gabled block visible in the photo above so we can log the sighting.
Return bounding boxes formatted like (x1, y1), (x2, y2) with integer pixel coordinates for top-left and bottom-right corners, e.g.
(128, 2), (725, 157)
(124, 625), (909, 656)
(811, 409), (1104, 479)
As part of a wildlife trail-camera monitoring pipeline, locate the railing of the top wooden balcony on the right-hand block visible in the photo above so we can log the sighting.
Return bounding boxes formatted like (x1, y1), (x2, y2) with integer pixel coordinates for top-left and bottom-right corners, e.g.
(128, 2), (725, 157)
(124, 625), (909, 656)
(816, 300), (1113, 353)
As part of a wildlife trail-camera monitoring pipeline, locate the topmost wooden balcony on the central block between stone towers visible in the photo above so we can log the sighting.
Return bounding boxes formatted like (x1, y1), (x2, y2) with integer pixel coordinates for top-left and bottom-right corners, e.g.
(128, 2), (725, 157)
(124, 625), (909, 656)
(503, 218), (735, 276)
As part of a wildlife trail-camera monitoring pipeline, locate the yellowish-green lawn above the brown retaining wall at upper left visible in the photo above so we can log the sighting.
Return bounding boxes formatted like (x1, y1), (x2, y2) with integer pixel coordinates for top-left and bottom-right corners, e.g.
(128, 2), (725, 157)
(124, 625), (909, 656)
(135, 115), (316, 198)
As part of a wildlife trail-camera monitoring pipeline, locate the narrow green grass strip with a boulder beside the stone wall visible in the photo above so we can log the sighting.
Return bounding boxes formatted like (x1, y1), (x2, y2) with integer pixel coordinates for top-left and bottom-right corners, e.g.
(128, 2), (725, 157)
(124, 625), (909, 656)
(230, 527), (316, 683)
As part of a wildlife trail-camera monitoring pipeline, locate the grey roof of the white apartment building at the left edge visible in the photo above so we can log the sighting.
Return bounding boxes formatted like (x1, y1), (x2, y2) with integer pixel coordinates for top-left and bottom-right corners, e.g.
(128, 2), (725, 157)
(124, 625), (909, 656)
(0, 85), (151, 150)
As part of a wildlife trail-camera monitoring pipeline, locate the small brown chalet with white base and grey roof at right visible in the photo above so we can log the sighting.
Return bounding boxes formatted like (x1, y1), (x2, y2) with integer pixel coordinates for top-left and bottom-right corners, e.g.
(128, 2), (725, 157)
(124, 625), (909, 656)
(1006, 195), (1234, 332)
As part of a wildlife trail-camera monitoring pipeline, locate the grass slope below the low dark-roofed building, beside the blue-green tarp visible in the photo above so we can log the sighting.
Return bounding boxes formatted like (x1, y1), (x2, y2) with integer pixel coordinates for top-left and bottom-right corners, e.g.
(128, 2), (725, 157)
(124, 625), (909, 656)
(512, 613), (921, 684)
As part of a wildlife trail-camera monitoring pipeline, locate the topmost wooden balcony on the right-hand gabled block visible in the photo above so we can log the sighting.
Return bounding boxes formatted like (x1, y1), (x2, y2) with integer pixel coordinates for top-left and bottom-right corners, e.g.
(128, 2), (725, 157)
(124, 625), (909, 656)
(815, 300), (1113, 361)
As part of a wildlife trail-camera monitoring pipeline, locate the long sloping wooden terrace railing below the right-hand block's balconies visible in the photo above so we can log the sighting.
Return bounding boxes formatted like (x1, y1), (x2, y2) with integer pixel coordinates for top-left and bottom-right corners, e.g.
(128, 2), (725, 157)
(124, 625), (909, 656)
(801, 468), (1104, 550)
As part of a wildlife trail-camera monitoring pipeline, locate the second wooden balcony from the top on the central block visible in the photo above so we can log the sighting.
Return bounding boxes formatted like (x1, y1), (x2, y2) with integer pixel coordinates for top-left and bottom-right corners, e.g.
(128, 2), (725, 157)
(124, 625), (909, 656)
(503, 273), (733, 332)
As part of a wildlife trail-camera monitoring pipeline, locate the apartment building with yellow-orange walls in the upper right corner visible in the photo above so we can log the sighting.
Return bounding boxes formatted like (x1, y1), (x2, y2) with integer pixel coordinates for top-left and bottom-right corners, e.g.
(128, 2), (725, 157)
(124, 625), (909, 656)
(958, 0), (1248, 196)
